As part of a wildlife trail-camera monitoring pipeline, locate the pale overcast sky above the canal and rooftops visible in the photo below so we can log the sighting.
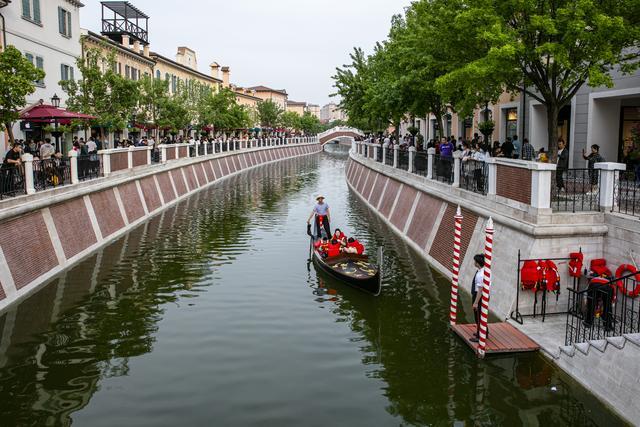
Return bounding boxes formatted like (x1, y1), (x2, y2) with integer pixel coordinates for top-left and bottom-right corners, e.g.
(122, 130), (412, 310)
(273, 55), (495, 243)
(80, 0), (410, 105)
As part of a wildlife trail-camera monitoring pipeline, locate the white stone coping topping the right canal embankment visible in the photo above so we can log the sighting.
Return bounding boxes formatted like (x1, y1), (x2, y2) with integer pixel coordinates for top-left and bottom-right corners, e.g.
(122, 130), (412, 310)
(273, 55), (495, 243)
(350, 153), (609, 237)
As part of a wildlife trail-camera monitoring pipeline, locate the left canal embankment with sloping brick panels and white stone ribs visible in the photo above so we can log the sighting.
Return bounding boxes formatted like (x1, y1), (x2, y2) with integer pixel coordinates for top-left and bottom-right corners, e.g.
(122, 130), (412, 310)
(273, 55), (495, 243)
(0, 143), (322, 310)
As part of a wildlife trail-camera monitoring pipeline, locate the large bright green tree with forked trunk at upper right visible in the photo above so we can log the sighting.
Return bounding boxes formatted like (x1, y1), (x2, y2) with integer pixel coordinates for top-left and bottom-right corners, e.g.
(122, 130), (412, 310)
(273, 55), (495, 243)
(441, 0), (640, 158)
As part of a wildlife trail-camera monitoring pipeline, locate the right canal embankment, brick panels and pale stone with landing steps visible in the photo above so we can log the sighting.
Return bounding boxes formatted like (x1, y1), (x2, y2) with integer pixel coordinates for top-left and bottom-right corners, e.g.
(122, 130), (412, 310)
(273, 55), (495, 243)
(346, 151), (640, 424)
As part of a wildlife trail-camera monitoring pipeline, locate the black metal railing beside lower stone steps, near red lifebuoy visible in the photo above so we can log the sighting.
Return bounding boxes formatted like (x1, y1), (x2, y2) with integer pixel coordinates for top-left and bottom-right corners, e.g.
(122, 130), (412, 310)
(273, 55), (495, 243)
(565, 273), (640, 345)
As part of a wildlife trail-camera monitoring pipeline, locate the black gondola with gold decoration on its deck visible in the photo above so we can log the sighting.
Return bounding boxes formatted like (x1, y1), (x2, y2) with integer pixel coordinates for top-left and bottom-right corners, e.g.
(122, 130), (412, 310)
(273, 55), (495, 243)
(308, 226), (382, 296)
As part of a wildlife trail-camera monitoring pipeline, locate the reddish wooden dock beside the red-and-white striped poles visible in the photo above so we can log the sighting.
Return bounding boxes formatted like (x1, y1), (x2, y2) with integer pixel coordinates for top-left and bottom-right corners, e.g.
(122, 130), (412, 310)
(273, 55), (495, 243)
(452, 322), (540, 355)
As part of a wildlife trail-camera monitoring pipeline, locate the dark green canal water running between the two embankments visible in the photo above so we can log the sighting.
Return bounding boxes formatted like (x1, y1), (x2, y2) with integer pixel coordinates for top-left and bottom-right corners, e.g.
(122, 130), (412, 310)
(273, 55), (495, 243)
(0, 146), (622, 426)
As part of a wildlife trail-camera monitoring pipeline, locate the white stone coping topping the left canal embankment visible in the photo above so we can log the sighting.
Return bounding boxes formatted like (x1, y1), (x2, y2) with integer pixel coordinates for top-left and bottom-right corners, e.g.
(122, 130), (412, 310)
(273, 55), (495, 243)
(0, 142), (319, 221)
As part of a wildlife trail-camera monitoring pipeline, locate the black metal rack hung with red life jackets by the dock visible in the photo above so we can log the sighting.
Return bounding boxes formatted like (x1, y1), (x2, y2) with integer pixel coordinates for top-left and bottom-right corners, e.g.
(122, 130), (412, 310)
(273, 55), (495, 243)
(509, 248), (583, 325)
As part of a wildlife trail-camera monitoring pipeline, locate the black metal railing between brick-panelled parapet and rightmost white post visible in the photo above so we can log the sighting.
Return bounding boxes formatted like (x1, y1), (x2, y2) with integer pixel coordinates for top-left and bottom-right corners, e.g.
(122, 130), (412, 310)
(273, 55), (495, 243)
(551, 168), (600, 212)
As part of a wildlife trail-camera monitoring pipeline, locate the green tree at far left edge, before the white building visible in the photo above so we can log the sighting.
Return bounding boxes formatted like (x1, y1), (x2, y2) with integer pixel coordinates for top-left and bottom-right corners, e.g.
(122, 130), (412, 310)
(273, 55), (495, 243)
(0, 46), (45, 144)
